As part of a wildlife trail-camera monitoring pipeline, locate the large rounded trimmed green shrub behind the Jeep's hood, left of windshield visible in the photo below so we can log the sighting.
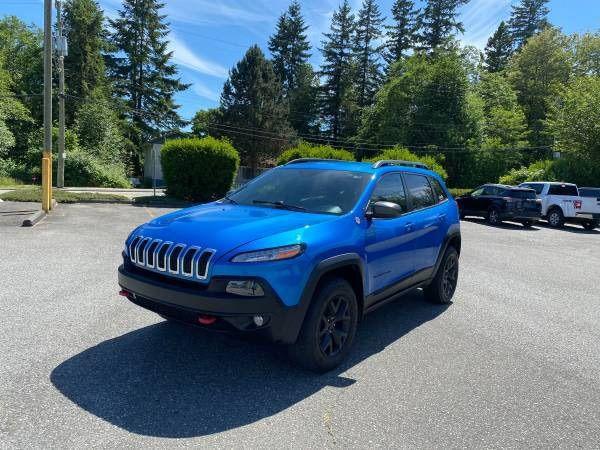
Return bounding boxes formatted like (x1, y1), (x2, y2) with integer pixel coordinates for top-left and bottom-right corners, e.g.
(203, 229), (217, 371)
(161, 137), (240, 202)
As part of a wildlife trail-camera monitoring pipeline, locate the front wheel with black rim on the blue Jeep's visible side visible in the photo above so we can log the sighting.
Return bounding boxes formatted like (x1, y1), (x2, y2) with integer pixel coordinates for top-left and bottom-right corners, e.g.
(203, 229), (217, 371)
(289, 278), (358, 373)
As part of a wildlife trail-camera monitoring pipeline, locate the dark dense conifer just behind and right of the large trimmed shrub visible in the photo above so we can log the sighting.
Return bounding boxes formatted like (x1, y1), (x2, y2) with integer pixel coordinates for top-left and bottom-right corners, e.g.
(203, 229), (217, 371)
(221, 45), (291, 169)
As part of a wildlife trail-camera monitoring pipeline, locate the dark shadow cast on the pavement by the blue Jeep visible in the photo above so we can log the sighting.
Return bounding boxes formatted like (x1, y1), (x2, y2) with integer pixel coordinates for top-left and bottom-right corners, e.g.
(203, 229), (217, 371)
(50, 291), (446, 438)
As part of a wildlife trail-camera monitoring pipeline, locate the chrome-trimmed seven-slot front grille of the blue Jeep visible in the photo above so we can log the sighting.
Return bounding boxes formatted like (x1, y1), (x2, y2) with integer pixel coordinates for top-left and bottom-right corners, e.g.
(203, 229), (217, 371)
(128, 236), (216, 280)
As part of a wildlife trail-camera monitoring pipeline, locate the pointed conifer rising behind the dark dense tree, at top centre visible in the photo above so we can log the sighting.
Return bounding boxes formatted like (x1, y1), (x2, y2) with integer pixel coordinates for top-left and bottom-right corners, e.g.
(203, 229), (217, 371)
(269, 0), (310, 93)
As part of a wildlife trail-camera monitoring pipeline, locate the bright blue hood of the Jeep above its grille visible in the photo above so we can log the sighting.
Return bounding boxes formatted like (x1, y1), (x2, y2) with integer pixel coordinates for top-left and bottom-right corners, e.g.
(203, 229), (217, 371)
(136, 203), (338, 254)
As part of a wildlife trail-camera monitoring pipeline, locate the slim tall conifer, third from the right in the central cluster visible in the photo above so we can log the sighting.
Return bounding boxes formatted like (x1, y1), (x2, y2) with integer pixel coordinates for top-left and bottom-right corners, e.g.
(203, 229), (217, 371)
(354, 0), (384, 108)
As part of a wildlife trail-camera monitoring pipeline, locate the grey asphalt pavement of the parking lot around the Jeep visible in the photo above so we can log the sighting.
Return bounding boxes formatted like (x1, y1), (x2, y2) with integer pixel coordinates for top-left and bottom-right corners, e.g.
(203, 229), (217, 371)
(0, 204), (600, 448)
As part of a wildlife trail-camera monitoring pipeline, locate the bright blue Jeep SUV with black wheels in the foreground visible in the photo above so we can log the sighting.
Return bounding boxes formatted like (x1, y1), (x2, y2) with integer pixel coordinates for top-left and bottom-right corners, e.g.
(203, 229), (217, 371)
(119, 159), (461, 372)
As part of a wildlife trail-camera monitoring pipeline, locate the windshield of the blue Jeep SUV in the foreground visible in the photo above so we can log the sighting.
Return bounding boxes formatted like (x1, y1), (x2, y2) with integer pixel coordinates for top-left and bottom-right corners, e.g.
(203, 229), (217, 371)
(227, 169), (371, 215)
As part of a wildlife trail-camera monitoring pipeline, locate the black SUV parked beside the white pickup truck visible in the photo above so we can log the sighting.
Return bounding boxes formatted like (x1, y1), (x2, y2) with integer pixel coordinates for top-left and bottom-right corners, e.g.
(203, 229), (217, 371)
(456, 184), (542, 227)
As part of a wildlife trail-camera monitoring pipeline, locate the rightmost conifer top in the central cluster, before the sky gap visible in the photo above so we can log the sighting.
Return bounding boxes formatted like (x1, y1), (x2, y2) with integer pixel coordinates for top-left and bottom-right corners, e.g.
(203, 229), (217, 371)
(418, 0), (469, 51)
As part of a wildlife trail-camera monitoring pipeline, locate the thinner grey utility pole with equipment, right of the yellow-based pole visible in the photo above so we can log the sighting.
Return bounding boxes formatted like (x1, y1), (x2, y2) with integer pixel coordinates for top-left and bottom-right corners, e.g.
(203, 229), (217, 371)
(56, 0), (67, 188)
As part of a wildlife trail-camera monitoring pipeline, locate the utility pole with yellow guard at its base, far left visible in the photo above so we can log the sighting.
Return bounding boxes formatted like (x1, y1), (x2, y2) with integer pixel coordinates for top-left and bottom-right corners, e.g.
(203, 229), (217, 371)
(42, 0), (52, 212)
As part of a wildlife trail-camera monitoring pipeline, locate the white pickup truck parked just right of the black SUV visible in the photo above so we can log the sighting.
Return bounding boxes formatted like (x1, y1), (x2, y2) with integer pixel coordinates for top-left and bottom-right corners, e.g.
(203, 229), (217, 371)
(519, 181), (600, 230)
